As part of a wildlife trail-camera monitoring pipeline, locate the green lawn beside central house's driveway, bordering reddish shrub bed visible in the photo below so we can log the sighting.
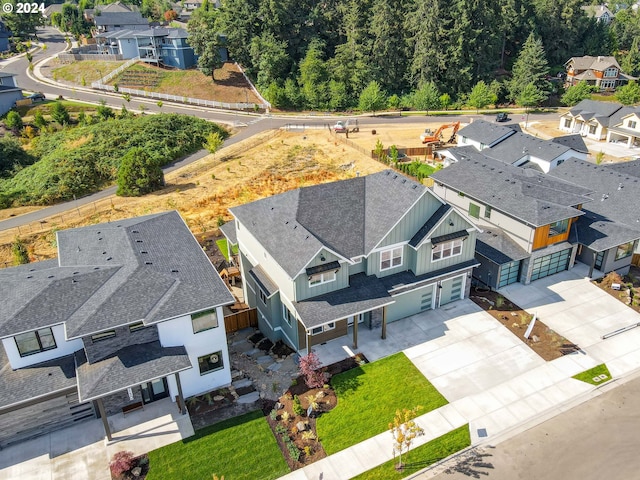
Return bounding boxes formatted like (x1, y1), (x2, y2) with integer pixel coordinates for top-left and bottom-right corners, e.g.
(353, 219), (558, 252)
(316, 352), (448, 455)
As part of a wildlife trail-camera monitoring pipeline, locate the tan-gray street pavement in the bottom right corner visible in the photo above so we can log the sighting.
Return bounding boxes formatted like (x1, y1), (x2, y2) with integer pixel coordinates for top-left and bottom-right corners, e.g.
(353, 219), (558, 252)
(422, 377), (640, 480)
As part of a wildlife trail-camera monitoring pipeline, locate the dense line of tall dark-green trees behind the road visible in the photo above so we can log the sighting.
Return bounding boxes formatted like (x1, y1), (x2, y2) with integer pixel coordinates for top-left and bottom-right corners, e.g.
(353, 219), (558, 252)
(195, 0), (640, 110)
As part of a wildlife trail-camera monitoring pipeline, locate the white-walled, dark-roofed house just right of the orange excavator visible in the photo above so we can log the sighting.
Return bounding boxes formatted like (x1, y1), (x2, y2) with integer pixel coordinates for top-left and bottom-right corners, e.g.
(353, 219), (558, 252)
(441, 120), (588, 173)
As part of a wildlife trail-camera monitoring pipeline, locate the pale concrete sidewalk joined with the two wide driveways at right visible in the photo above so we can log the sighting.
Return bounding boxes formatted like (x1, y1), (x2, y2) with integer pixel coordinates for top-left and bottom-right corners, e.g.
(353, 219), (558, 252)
(282, 264), (640, 480)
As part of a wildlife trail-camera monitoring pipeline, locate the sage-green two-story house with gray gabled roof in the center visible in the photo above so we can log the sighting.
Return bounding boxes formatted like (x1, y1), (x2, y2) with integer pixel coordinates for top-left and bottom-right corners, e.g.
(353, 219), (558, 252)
(223, 170), (477, 353)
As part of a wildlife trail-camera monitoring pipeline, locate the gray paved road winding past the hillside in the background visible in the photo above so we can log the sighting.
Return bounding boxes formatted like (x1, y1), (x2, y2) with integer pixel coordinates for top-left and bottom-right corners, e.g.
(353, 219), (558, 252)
(0, 27), (544, 231)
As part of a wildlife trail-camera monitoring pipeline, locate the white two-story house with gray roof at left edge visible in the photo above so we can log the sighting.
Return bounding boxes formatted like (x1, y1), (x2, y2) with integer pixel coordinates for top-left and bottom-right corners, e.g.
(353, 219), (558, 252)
(0, 211), (234, 445)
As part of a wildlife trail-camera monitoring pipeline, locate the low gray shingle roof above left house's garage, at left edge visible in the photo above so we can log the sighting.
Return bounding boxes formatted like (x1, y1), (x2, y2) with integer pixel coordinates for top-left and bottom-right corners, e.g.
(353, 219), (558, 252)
(0, 342), (76, 409)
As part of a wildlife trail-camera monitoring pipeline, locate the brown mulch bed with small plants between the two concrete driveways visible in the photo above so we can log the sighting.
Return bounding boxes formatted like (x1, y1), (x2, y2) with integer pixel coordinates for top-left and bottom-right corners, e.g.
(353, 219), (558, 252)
(469, 289), (580, 361)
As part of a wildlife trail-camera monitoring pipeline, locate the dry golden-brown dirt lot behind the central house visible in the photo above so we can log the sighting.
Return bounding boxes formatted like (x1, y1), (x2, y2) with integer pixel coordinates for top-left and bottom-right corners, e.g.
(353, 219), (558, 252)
(0, 131), (385, 265)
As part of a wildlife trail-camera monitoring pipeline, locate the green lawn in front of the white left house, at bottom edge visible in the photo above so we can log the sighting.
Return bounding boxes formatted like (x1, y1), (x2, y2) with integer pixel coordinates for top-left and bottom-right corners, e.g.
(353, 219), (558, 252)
(147, 410), (289, 480)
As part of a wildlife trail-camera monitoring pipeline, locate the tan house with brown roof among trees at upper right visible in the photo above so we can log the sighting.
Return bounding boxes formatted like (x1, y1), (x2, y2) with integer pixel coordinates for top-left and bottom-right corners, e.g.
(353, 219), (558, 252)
(564, 55), (637, 90)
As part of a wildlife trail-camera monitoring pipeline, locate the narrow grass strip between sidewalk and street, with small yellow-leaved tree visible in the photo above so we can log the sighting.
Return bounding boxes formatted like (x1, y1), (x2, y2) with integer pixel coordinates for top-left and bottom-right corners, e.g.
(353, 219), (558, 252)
(351, 424), (471, 480)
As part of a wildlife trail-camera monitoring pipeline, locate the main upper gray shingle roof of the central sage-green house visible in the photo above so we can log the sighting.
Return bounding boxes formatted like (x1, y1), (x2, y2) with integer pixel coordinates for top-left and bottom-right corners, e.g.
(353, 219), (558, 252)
(231, 170), (426, 278)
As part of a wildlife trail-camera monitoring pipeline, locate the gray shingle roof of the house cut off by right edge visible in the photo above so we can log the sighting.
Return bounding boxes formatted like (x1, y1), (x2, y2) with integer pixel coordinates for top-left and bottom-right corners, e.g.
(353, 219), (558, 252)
(549, 158), (640, 251)
